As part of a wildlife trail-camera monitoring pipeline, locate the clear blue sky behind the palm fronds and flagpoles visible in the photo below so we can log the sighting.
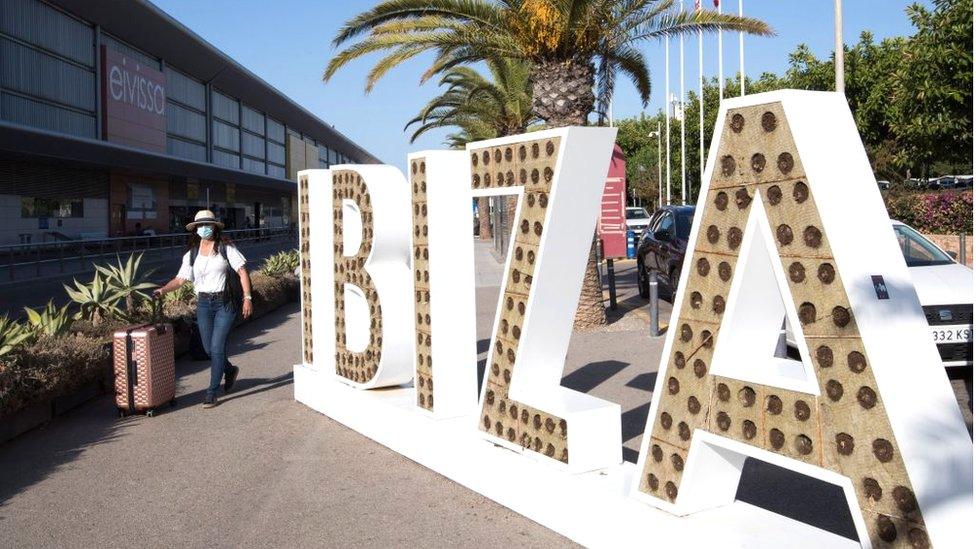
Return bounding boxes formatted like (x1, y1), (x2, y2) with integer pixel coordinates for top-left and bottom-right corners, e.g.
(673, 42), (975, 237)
(152, 0), (930, 166)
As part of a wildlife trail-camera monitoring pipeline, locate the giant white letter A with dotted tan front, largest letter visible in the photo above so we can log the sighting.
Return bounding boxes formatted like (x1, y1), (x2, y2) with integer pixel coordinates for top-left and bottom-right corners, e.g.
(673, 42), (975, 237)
(634, 90), (973, 547)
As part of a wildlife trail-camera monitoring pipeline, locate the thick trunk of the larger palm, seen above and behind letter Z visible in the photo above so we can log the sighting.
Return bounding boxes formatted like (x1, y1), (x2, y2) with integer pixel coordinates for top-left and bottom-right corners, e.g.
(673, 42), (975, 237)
(531, 59), (607, 329)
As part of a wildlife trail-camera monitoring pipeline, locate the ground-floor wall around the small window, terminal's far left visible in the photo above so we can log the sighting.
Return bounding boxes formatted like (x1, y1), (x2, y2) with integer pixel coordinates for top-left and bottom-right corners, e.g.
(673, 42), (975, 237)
(0, 194), (108, 245)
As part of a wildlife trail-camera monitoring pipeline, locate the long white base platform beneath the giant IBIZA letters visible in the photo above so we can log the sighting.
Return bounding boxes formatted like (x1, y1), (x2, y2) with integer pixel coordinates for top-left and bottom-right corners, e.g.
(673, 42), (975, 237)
(295, 365), (859, 549)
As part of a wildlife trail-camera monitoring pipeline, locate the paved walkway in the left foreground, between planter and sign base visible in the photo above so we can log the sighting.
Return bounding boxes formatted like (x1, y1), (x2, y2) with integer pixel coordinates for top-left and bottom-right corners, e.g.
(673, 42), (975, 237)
(0, 305), (569, 547)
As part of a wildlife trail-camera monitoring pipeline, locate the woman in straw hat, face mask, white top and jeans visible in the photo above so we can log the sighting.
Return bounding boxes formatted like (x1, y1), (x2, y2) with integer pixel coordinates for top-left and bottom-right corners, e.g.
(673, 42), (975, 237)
(155, 210), (251, 408)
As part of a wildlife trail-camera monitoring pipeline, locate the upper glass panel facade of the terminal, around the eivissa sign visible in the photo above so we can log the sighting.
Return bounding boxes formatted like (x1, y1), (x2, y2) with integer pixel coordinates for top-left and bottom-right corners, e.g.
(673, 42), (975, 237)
(0, 0), (368, 178)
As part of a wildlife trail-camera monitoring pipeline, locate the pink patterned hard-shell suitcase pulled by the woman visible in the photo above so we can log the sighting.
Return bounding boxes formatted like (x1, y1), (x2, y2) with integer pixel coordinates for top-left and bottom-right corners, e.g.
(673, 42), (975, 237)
(112, 323), (176, 417)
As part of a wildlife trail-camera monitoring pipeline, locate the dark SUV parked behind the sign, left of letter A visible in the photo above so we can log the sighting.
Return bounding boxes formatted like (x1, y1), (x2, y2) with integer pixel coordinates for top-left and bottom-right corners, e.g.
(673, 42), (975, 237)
(637, 206), (695, 299)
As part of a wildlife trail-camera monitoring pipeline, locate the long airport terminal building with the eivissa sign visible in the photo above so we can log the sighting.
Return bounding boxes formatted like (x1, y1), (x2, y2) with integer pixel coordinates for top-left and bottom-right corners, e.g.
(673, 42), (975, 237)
(0, 0), (377, 245)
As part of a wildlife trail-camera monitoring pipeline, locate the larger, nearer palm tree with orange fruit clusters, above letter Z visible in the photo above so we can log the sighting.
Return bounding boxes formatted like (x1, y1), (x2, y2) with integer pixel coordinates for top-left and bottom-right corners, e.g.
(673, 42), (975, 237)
(324, 0), (772, 327)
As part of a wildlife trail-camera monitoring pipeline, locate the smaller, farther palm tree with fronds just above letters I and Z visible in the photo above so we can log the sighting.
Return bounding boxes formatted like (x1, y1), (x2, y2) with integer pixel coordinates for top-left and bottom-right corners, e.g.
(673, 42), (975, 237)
(404, 59), (536, 240)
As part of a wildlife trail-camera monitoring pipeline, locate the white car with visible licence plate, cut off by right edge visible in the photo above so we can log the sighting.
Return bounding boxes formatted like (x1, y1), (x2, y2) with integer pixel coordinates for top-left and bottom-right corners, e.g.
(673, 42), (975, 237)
(891, 220), (973, 366)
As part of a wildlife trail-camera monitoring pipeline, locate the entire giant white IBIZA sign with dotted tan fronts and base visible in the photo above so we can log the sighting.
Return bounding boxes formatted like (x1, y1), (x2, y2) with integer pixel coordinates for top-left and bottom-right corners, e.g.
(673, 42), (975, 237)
(295, 91), (972, 547)
